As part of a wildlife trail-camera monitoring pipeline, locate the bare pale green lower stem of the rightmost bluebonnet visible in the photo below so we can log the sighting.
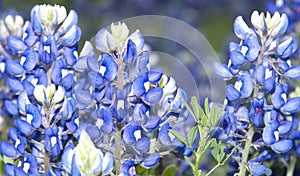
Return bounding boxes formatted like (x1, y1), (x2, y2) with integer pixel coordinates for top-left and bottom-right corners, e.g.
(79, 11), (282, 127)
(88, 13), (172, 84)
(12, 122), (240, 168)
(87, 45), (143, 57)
(238, 125), (254, 176)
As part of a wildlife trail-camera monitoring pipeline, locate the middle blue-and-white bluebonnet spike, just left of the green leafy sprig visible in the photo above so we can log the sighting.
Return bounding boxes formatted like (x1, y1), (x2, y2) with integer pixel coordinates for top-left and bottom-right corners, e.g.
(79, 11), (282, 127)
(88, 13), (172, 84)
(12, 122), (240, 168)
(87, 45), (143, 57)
(74, 22), (188, 175)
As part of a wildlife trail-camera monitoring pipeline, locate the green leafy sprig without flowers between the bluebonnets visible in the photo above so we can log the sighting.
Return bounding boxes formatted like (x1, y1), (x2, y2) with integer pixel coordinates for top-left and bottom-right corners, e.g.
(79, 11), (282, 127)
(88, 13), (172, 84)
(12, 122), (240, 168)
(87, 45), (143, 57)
(171, 97), (235, 176)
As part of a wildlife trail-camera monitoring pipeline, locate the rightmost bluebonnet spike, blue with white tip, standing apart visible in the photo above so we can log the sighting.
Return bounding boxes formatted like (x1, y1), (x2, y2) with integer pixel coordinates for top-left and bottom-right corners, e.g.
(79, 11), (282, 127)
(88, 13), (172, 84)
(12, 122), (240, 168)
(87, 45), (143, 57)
(214, 11), (300, 175)
